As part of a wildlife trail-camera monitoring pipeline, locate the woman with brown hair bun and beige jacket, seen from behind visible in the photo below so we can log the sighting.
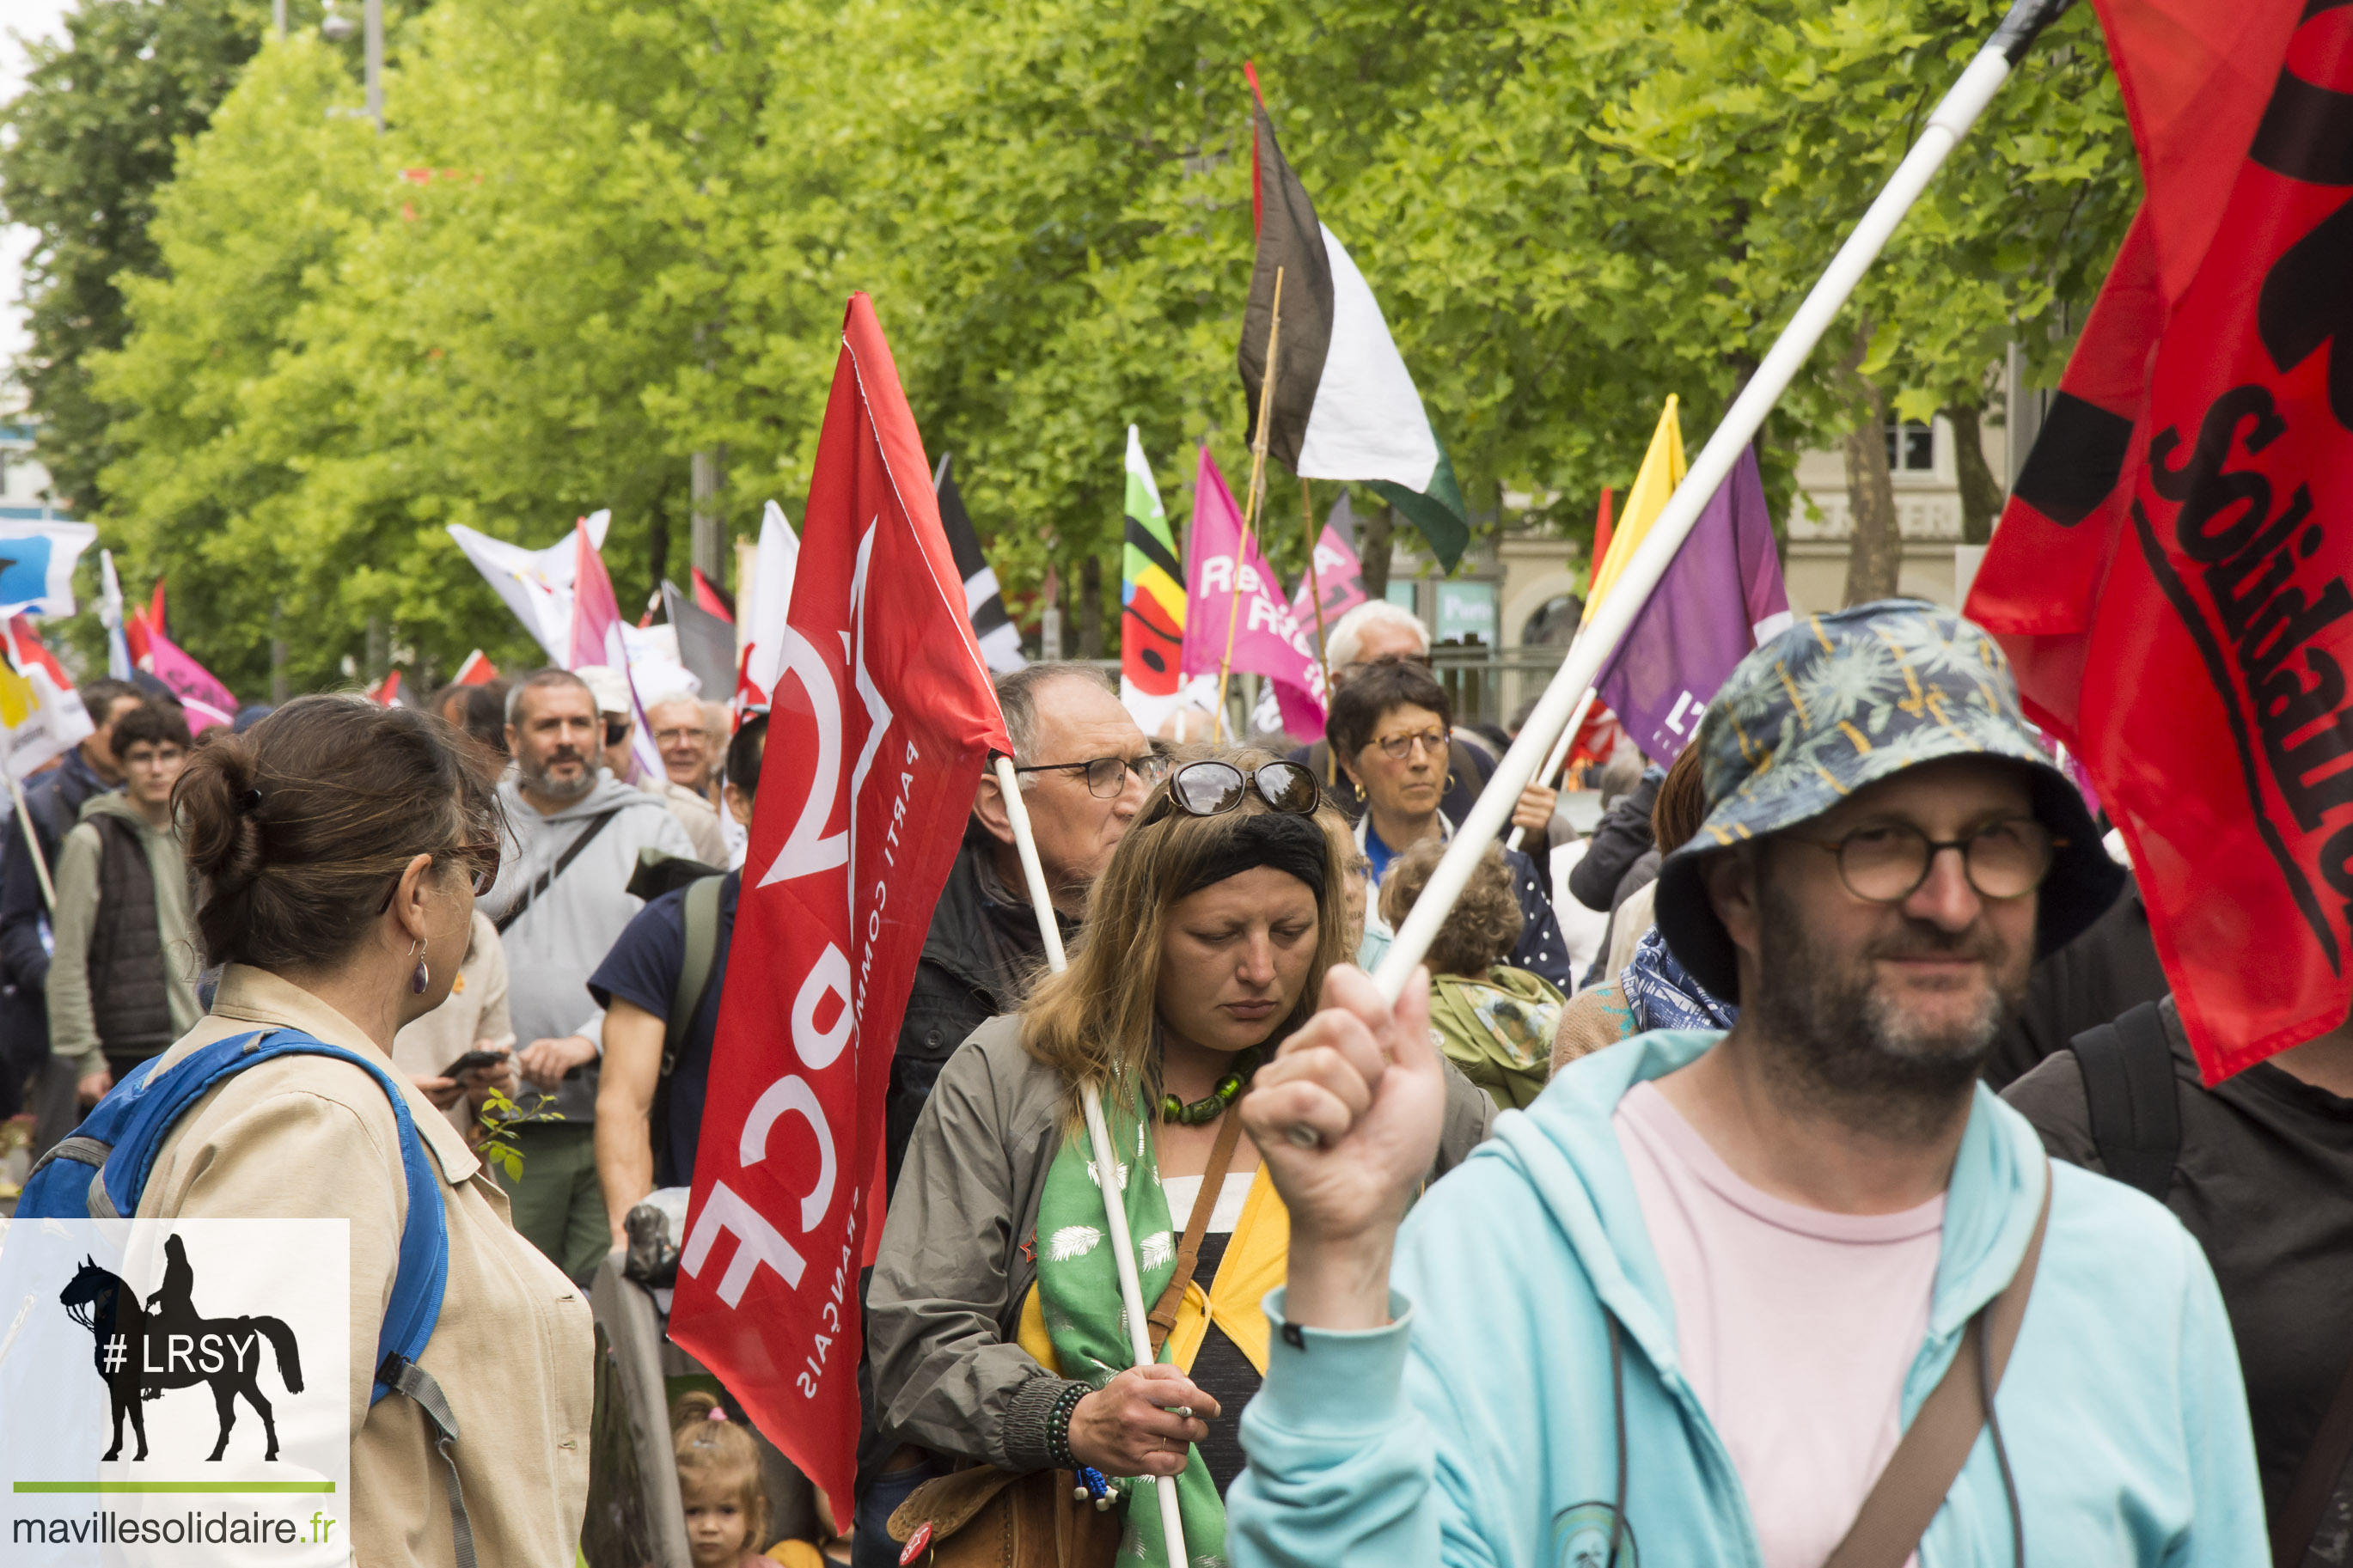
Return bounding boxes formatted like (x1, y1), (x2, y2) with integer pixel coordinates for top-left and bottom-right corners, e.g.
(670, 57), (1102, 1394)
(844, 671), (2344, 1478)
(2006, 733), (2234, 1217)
(103, 696), (593, 1564)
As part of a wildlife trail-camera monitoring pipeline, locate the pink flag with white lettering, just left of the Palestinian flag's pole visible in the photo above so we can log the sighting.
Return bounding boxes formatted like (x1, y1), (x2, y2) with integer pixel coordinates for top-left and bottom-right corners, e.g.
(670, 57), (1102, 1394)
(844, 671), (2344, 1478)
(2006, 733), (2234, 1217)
(1183, 447), (1324, 741)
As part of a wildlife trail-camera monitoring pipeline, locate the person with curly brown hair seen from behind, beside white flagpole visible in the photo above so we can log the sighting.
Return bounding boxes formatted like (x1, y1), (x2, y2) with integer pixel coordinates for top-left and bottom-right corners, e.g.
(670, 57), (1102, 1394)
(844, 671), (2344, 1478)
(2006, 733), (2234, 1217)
(1381, 839), (1568, 1109)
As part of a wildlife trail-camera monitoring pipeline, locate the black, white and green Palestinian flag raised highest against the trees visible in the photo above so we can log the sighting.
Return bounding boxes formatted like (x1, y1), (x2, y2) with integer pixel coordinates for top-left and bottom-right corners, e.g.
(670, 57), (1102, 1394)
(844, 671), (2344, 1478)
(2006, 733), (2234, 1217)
(1243, 66), (1470, 569)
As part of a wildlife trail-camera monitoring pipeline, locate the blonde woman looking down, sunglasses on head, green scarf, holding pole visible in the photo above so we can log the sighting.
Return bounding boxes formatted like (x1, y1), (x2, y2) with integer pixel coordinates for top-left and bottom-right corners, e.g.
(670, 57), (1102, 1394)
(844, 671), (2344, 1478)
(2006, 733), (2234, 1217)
(866, 750), (1494, 1564)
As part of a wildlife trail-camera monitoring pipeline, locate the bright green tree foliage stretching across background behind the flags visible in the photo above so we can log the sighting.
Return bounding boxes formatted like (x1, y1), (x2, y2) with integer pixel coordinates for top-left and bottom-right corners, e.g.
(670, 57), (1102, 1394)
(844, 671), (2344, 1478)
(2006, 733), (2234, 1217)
(69, 0), (2136, 681)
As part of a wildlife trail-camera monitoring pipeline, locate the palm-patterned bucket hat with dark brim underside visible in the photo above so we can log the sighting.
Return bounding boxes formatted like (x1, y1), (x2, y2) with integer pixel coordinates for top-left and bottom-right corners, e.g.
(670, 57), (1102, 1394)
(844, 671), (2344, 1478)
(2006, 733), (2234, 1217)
(1652, 600), (2124, 997)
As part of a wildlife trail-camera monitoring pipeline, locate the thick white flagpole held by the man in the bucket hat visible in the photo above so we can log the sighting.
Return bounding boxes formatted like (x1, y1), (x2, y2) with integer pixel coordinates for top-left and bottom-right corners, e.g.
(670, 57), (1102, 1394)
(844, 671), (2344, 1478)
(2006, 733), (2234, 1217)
(1373, 0), (2069, 1006)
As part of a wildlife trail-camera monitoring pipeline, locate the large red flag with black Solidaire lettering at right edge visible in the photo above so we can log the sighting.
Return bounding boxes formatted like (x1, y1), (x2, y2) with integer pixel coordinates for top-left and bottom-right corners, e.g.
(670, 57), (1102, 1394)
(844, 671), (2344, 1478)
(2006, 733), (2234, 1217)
(1970, 0), (2353, 1082)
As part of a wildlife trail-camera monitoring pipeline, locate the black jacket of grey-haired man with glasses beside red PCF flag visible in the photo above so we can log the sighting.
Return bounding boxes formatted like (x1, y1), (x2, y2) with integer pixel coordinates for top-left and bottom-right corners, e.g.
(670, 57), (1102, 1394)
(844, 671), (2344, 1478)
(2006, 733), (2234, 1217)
(883, 841), (1078, 1192)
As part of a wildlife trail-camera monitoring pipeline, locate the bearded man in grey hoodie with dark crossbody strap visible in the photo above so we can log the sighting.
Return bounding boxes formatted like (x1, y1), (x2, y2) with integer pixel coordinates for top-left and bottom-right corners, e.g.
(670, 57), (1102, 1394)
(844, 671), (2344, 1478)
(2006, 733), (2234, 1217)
(482, 670), (694, 1278)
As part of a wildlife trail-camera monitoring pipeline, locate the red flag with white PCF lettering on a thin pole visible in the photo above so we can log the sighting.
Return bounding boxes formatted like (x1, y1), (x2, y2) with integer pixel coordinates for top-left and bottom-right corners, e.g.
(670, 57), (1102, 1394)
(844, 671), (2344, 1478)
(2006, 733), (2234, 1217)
(670, 294), (1011, 1516)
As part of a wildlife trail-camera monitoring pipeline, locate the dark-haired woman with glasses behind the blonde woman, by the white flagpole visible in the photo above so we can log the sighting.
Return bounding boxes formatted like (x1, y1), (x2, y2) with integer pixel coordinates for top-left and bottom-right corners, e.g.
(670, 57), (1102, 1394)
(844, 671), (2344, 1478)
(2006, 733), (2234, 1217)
(1324, 661), (1576, 992)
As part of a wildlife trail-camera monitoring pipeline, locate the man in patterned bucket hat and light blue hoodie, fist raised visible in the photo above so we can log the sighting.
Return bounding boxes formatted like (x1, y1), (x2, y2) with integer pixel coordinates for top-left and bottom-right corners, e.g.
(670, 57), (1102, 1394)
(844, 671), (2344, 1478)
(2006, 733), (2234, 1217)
(1231, 601), (2266, 1568)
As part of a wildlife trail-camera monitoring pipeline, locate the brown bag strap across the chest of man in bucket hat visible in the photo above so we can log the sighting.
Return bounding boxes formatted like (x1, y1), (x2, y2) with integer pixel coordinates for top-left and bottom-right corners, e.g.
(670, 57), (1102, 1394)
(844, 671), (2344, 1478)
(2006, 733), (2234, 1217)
(1824, 1166), (2052, 1568)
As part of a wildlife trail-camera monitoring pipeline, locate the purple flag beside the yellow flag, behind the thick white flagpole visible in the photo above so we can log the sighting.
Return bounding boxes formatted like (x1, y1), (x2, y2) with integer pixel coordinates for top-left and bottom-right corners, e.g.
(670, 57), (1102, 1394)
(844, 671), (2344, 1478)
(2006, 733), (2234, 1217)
(1593, 447), (1788, 764)
